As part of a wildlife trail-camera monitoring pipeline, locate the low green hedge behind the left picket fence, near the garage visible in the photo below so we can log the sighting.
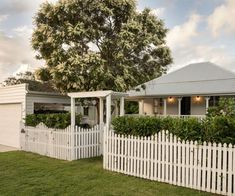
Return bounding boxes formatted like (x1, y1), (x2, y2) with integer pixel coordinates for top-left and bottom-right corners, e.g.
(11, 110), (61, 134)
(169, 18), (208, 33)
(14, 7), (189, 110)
(25, 113), (81, 129)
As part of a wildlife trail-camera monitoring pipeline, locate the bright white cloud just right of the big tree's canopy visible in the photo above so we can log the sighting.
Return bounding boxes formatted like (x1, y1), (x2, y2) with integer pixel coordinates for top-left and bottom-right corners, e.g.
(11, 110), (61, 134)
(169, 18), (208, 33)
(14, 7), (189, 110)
(166, 13), (202, 48)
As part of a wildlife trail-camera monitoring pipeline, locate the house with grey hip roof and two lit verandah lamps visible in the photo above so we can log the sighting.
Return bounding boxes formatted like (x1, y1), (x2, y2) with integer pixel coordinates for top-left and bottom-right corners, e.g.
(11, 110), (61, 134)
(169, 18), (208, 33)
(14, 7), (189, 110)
(128, 62), (235, 117)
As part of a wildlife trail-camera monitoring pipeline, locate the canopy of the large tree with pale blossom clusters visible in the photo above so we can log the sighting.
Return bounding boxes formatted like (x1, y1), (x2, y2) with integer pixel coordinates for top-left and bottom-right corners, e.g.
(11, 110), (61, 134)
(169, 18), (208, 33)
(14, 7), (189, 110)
(32, 0), (172, 92)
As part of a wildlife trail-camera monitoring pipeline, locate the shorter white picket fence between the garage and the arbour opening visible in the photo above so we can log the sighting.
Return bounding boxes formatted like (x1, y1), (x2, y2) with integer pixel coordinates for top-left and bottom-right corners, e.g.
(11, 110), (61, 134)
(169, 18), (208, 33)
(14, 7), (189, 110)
(20, 124), (105, 160)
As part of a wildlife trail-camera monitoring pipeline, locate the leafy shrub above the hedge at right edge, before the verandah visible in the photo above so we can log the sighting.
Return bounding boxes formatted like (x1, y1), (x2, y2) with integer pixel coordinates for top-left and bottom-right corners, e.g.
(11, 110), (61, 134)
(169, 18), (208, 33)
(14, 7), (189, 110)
(207, 97), (235, 117)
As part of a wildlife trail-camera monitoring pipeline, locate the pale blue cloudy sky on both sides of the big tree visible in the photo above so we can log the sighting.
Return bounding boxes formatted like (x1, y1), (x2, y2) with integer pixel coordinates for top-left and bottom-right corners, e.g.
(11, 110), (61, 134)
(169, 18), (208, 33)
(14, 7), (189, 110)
(0, 0), (235, 82)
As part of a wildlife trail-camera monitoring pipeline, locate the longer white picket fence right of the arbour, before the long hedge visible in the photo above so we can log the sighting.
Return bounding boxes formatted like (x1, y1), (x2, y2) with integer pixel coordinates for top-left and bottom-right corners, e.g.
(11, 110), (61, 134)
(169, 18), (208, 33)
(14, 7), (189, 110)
(103, 130), (235, 195)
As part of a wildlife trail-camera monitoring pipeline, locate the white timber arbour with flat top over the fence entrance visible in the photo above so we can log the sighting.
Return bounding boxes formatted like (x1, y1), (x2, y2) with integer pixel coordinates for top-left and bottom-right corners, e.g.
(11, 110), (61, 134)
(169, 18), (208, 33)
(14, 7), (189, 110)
(68, 90), (128, 130)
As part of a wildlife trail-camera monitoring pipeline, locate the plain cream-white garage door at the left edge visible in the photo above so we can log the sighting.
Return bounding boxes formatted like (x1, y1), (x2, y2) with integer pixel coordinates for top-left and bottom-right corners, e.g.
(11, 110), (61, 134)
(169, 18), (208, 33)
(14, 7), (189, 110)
(0, 104), (21, 148)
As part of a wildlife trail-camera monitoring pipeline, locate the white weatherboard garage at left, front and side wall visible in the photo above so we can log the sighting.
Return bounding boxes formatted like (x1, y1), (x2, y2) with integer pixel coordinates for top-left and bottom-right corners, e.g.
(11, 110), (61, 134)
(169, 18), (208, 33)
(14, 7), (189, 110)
(0, 84), (70, 148)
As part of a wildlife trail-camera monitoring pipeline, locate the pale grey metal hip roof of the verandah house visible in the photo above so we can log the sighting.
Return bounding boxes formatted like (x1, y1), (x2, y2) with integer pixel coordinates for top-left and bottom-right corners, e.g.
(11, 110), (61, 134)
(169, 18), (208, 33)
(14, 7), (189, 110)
(128, 62), (235, 96)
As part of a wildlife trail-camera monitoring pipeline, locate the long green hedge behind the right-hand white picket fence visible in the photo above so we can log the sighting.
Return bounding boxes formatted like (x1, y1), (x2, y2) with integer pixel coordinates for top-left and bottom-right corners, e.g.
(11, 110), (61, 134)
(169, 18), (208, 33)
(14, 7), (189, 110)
(112, 116), (235, 144)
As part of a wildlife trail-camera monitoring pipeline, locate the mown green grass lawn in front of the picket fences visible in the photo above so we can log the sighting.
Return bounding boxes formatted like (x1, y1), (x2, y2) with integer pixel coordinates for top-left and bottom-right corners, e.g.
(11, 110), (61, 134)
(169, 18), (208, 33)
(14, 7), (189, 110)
(0, 151), (214, 196)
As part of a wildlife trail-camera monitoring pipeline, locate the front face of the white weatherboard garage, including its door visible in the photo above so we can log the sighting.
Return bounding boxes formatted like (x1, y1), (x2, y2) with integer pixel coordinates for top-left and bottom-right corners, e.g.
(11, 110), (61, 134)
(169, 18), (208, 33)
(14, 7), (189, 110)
(0, 84), (27, 148)
